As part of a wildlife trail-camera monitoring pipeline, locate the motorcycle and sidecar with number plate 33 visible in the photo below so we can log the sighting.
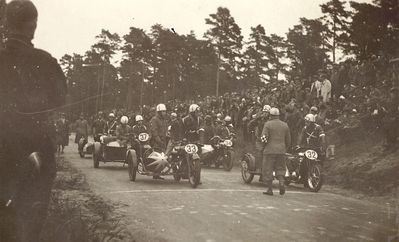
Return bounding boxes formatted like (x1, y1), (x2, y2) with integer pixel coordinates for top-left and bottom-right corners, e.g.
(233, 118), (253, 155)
(126, 137), (201, 188)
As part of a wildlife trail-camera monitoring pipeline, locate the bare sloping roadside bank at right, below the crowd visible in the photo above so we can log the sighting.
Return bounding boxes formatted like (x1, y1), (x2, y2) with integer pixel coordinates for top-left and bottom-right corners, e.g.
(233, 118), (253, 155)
(325, 127), (399, 199)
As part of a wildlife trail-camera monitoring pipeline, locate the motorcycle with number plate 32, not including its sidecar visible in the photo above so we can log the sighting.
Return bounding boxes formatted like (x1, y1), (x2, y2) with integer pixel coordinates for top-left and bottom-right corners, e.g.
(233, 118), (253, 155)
(285, 148), (323, 192)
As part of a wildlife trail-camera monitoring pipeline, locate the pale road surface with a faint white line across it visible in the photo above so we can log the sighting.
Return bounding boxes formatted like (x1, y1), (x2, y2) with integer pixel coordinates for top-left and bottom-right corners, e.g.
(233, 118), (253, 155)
(63, 142), (399, 242)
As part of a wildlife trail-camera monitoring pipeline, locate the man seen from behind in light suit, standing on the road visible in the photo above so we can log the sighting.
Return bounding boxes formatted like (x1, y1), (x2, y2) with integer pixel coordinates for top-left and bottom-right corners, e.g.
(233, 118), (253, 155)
(262, 108), (291, 195)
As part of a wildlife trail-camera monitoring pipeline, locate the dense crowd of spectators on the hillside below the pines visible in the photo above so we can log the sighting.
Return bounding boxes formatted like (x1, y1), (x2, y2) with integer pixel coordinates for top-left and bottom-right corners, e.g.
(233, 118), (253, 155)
(61, 56), (399, 152)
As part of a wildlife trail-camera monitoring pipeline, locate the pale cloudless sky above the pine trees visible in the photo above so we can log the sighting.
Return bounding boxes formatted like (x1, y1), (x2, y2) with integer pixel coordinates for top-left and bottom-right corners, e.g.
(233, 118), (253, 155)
(11, 0), (371, 59)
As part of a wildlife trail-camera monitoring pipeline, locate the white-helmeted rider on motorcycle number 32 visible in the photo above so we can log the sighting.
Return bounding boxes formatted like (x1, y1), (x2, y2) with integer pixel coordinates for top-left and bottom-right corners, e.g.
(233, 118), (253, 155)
(298, 113), (326, 151)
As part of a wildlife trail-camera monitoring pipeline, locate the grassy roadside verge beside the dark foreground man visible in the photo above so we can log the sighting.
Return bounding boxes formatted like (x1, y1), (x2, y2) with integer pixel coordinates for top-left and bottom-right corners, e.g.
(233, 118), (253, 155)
(42, 157), (136, 242)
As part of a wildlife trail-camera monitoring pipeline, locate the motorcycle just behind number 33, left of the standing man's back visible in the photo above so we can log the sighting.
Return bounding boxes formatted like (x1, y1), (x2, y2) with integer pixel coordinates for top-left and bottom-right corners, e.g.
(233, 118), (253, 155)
(201, 136), (233, 171)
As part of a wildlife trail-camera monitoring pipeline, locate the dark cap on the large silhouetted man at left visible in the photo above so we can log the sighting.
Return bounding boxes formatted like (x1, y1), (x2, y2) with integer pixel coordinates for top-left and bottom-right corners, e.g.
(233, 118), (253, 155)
(6, 0), (38, 27)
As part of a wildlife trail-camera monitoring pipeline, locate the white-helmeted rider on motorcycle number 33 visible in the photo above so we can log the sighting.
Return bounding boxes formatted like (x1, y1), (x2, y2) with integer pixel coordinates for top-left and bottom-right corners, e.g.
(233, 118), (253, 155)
(183, 104), (203, 142)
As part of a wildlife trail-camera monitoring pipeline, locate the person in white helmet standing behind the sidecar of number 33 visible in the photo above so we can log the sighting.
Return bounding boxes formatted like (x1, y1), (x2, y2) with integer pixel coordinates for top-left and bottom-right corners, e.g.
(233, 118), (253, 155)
(150, 103), (168, 151)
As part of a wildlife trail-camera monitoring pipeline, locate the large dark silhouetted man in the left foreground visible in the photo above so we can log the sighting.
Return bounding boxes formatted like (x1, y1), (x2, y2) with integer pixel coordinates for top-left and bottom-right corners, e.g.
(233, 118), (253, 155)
(0, 0), (66, 242)
